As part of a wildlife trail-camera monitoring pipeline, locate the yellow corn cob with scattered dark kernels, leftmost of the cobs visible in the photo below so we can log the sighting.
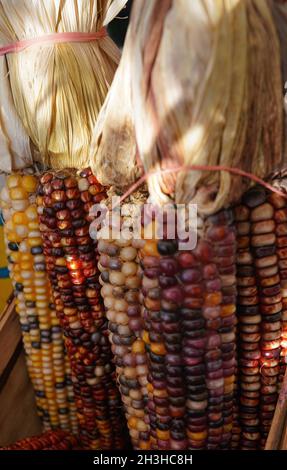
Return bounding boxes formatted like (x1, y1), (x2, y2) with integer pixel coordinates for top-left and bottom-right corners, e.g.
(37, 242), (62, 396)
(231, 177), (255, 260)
(1, 174), (77, 433)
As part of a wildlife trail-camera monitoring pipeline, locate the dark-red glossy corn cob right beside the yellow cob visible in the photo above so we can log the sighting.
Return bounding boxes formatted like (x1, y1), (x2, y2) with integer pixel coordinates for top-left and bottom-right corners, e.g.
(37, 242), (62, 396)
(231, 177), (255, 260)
(37, 170), (124, 449)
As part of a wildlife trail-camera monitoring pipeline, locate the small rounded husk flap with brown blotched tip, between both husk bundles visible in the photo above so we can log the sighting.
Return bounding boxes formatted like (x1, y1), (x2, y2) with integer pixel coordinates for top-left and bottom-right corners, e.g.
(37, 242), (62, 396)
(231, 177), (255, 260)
(90, 22), (138, 188)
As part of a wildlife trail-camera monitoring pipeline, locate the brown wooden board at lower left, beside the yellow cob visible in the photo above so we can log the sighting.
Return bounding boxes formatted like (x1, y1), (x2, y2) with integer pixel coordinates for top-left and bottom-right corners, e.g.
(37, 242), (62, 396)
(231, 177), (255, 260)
(0, 303), (41, 446)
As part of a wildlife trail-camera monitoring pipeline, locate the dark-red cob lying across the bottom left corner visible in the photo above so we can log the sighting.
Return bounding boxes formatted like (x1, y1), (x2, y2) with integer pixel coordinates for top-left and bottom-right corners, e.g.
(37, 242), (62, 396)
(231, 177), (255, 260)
(0, 430), (80, 450)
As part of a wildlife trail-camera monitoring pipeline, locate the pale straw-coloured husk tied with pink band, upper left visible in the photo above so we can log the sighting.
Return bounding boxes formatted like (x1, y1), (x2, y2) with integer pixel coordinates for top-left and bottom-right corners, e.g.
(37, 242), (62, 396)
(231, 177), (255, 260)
(0, 0), (126, 169)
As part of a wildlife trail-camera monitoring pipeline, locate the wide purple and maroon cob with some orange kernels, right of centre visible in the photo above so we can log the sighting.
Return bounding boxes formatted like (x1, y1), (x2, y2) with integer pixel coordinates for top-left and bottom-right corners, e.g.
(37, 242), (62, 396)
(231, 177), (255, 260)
(139, 207), (236, 450)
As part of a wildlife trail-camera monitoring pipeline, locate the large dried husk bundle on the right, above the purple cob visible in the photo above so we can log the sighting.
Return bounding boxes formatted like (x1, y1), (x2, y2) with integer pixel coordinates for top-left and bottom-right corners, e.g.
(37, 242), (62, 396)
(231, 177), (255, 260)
(91, 0), (283, 214)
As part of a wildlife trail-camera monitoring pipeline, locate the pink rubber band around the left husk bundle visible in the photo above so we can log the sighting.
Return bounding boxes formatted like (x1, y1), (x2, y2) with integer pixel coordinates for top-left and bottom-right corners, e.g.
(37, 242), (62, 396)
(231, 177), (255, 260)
(0, 28), (107, 56)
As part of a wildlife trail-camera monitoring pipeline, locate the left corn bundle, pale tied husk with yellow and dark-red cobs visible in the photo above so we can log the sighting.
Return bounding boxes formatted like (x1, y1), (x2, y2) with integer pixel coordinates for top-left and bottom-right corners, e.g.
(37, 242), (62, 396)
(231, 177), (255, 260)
(0, 0), (129, 449)
